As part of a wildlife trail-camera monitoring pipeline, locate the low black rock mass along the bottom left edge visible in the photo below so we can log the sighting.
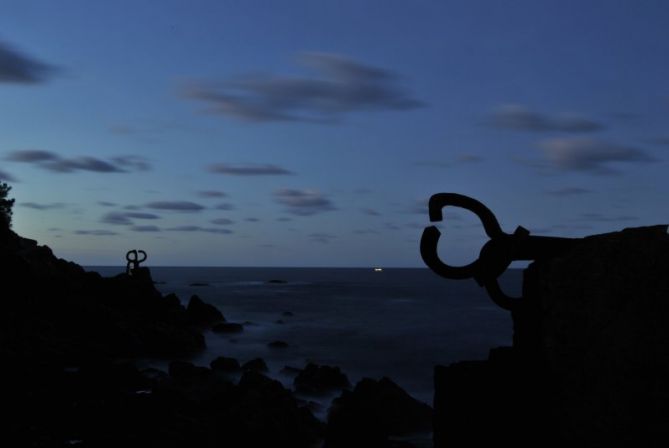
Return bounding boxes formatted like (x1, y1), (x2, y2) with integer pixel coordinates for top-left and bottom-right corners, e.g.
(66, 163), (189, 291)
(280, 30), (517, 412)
(2, 363), (323, 447)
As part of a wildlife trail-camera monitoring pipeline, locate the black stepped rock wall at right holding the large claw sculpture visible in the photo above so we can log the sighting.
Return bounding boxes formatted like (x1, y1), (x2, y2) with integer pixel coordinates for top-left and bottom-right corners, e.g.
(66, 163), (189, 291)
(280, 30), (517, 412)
(435, 226), (669, 447)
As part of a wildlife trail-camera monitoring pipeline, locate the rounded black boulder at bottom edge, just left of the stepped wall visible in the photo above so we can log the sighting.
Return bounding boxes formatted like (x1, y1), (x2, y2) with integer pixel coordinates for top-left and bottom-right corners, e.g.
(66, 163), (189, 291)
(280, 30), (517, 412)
(325, 378), (432, 448)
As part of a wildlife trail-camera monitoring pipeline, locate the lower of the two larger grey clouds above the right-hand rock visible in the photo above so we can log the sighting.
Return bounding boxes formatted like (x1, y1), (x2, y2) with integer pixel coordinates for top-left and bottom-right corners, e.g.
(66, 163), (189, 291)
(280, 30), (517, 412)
(539, 138), (656, 174)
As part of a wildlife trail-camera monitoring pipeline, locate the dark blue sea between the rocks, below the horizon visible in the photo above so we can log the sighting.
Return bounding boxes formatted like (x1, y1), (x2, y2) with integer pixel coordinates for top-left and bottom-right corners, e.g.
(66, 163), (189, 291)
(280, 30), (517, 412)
(90, 267), (522, 404)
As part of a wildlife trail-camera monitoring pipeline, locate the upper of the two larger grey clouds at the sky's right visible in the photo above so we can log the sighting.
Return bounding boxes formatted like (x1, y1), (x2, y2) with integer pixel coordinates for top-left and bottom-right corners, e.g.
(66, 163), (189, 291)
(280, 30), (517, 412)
(489, 104), (604, 132)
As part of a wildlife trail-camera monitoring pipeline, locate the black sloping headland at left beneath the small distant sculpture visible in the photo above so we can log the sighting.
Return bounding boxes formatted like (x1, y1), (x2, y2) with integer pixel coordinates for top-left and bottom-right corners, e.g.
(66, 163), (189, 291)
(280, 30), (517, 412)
(0, 231), (211, 363)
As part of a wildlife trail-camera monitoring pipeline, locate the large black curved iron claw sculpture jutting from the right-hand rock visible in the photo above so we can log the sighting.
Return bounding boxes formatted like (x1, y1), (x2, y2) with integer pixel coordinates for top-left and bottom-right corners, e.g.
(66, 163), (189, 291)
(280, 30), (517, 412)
(420, 193), (580, 310)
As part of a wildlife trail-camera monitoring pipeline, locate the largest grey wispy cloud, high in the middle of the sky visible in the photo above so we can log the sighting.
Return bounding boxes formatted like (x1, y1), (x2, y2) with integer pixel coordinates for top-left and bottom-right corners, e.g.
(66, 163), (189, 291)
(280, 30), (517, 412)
(184, 53), (423, 123)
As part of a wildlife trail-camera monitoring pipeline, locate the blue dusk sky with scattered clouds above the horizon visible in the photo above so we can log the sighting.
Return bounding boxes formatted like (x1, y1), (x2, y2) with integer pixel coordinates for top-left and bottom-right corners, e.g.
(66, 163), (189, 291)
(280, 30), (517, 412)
(0, 0), (669, 267)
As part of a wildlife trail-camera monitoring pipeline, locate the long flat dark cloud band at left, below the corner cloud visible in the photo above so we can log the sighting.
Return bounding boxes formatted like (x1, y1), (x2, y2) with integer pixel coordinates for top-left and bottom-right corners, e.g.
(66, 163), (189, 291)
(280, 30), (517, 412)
(5, 149), (148, 173)
